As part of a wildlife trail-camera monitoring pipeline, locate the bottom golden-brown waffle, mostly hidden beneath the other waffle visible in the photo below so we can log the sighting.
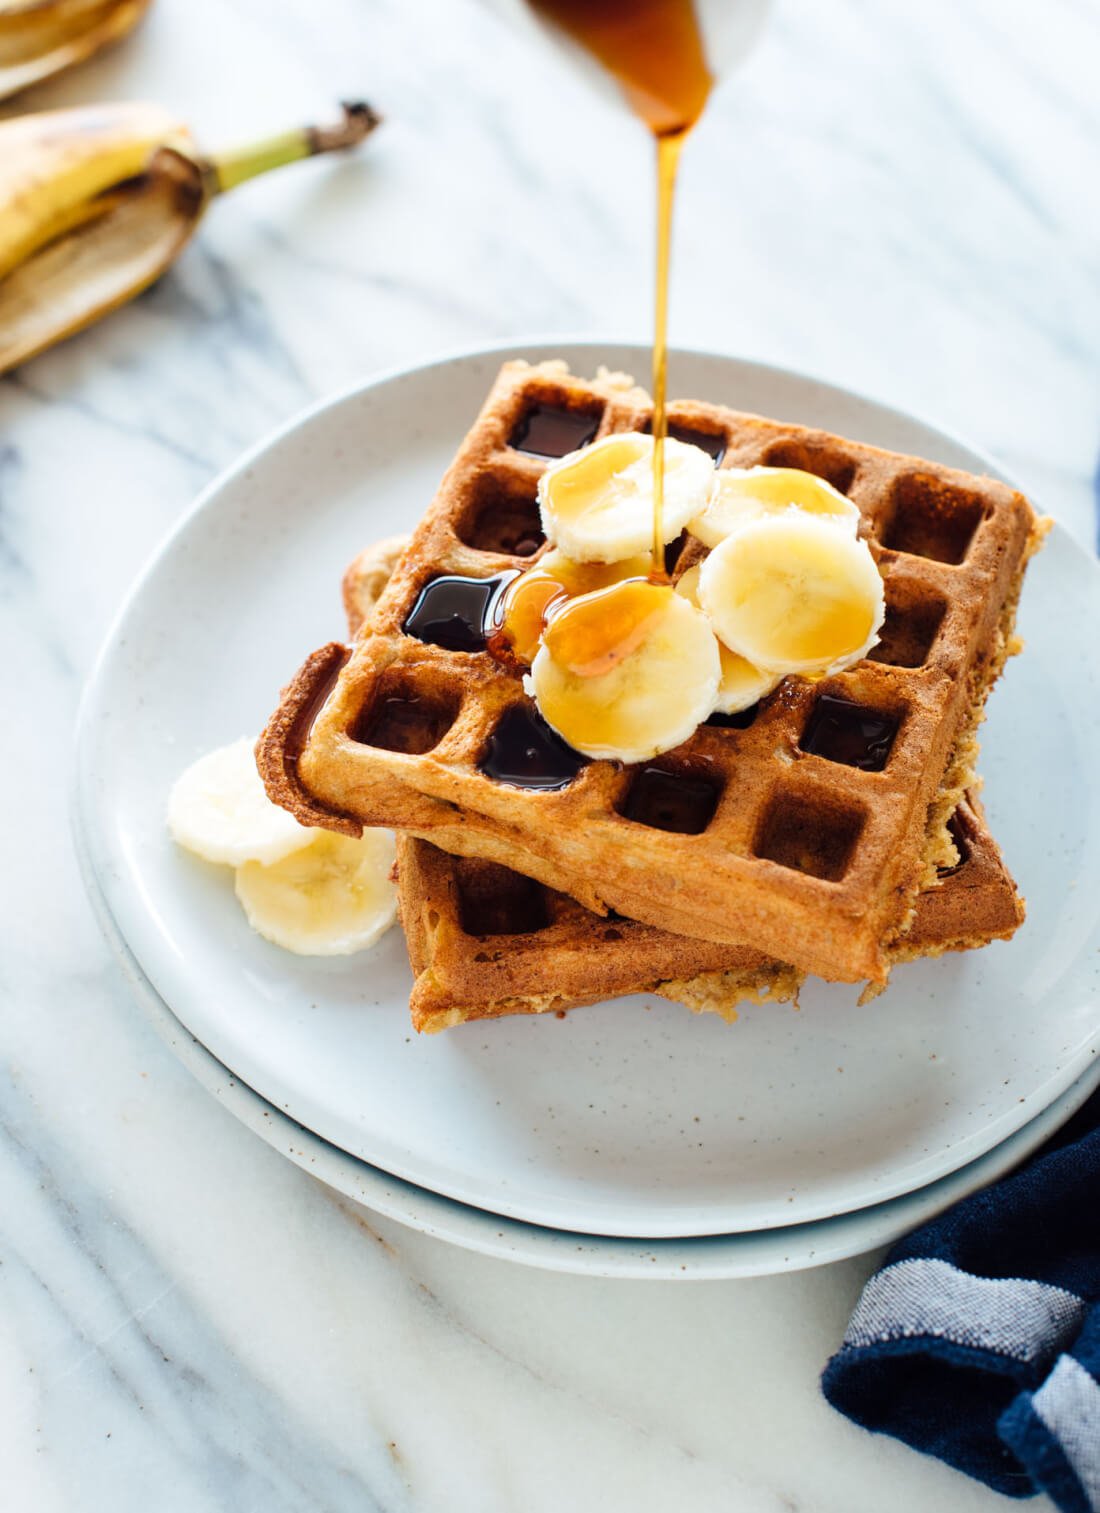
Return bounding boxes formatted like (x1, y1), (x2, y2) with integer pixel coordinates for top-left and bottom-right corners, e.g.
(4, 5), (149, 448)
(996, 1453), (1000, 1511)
(398, 796), (1024, 1032)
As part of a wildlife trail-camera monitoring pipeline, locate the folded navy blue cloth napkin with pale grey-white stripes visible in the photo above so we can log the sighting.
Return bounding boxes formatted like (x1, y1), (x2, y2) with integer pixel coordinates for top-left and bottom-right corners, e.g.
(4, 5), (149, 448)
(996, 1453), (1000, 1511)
(822, 1092), (1100, 1513)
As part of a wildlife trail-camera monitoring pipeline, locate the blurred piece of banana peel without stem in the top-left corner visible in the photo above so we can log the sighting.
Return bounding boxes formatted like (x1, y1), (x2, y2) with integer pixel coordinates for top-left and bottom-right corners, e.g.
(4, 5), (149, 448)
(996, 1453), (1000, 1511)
(0, 0), (150, 100)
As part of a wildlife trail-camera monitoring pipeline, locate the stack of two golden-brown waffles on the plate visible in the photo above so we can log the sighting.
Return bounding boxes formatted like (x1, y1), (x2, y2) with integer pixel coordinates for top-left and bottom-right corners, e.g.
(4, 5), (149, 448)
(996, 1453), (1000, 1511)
(257, 363), (1041, 1030)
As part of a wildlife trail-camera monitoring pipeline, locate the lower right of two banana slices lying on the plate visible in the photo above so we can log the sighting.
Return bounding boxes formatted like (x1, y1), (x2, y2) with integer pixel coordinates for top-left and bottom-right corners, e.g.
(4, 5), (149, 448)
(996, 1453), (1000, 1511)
(236, 831), (396, 956)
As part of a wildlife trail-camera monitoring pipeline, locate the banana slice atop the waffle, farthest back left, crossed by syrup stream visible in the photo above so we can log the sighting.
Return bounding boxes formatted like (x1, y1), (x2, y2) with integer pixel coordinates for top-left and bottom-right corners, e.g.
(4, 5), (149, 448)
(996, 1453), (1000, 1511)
(539, 431), (714, 563)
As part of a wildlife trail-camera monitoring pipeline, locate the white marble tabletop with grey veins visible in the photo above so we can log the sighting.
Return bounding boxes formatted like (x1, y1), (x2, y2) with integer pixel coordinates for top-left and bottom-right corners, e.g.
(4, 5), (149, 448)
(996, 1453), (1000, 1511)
(0, 0), (1100, 1513)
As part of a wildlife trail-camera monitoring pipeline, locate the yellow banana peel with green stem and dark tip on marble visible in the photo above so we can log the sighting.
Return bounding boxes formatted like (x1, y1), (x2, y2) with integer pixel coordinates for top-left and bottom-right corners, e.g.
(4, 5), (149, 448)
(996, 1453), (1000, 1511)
(0, 99), (380, 374)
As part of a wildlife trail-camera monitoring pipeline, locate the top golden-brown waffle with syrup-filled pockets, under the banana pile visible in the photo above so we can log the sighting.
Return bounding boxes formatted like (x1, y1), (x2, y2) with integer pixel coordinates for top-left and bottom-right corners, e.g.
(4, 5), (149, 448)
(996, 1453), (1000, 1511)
(259, 363), (1041, 982)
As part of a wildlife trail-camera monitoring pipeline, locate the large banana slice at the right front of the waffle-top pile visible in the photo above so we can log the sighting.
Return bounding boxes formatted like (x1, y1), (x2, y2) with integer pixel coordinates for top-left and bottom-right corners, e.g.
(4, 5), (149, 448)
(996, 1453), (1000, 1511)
(699, 510), (885, 673)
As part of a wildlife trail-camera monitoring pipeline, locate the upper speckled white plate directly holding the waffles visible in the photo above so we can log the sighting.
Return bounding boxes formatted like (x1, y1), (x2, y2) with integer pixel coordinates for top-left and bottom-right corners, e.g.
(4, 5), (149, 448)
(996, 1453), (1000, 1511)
(77, 343), (1100, 1239)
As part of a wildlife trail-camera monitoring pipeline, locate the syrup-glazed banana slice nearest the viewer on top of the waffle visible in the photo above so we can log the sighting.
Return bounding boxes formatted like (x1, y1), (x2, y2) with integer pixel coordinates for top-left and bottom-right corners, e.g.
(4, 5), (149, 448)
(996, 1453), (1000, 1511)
(524, 578), (722, 763)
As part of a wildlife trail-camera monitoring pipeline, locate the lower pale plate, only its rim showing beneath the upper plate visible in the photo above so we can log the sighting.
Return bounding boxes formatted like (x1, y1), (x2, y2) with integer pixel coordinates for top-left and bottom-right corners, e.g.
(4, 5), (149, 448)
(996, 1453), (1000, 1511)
(77, 829), (1100, 1282)
